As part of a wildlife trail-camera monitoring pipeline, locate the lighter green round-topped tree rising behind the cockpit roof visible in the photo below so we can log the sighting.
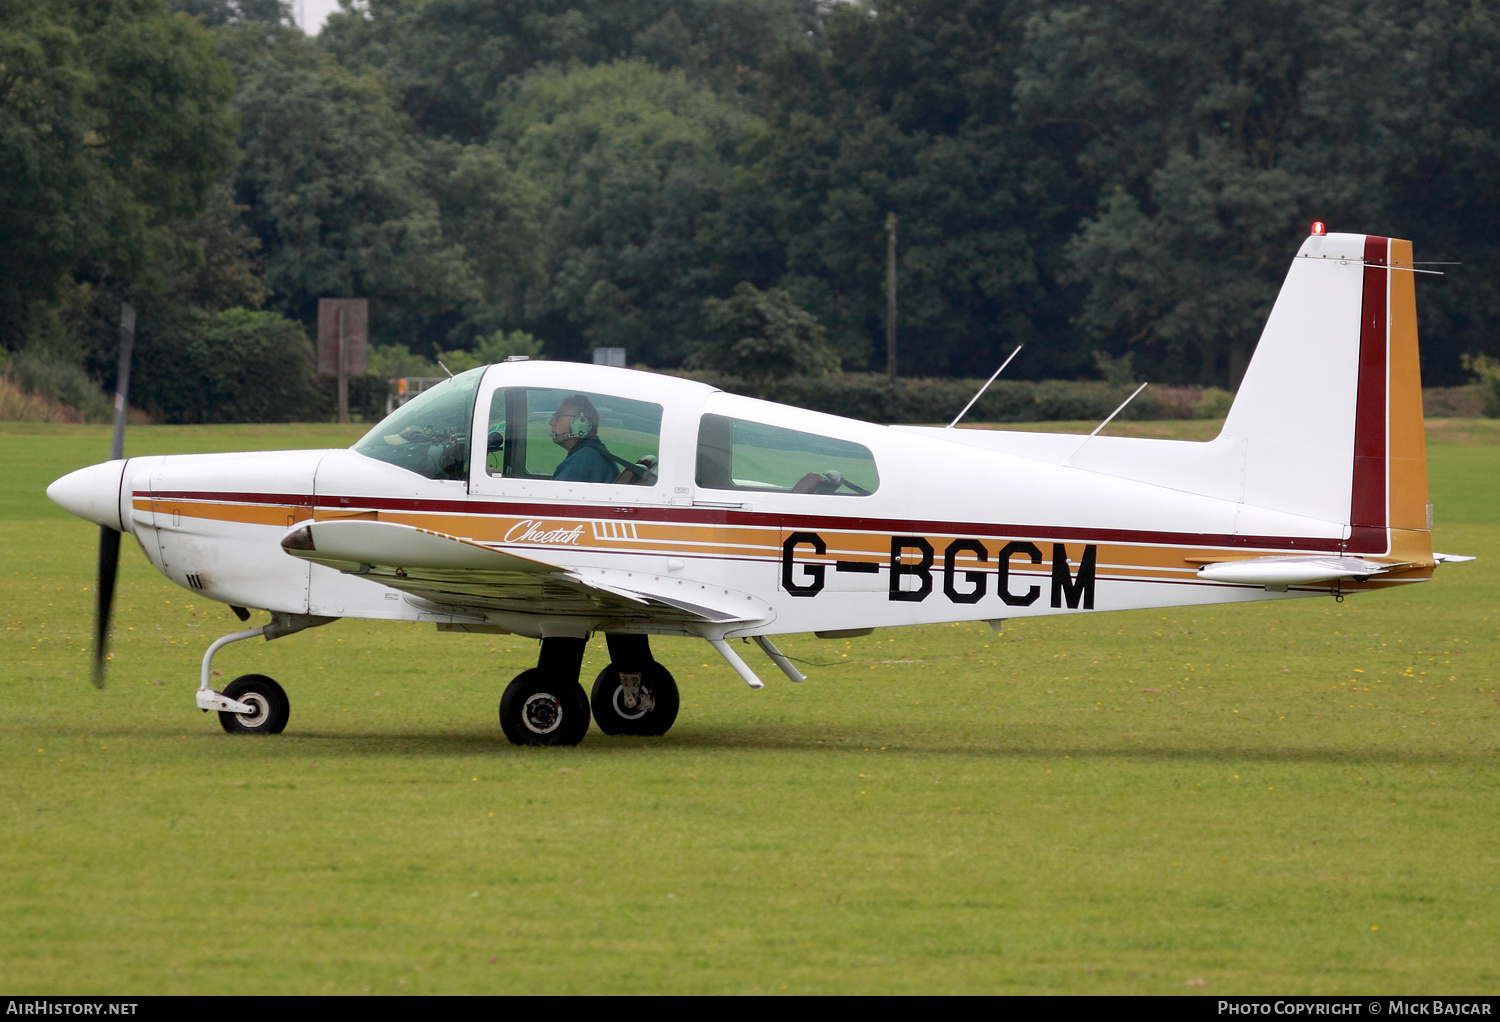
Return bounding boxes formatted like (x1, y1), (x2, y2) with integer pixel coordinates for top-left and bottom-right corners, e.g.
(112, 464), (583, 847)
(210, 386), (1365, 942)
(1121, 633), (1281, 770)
(497, 60), (764, 365)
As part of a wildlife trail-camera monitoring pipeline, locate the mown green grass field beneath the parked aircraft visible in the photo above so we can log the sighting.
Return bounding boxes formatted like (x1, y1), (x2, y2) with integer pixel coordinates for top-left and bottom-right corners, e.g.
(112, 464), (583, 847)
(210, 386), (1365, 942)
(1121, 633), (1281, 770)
(0, 420), (1500, 995)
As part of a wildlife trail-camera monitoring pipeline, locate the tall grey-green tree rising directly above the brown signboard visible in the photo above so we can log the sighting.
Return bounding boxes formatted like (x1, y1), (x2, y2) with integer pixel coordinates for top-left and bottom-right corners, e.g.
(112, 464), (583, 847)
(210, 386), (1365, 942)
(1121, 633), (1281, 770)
(219, 26), (479, 333)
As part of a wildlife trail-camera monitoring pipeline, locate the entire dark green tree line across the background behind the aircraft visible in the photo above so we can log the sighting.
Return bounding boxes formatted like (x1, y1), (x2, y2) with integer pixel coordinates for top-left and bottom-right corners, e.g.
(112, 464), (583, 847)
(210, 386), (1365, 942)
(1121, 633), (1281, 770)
(0, 0), (1500, 420)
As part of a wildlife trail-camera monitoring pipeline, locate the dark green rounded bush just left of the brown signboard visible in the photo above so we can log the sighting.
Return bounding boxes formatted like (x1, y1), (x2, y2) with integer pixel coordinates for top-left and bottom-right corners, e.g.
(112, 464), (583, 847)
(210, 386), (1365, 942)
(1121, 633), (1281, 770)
(132, 309), (321, 423)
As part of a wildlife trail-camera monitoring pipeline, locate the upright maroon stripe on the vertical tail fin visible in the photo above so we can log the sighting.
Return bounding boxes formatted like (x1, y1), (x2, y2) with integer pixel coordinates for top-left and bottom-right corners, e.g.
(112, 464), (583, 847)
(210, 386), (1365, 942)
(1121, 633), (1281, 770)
(1349, 234), (1391, 534)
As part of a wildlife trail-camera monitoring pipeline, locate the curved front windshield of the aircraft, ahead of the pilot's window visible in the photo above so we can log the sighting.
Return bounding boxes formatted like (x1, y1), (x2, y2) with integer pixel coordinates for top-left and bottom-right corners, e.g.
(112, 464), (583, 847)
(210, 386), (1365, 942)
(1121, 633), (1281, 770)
(354, 366), (485, 479)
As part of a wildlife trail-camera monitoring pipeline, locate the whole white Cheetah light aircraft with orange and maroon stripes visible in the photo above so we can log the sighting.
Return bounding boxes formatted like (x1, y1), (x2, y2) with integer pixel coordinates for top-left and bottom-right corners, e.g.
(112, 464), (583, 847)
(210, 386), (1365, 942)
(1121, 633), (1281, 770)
(47, 225), (1467, 744)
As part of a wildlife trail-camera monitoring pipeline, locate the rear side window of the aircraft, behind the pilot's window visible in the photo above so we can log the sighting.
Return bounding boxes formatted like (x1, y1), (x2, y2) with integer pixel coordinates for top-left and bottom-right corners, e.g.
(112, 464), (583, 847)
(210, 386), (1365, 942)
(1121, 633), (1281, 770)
(698, 414), (881, 495)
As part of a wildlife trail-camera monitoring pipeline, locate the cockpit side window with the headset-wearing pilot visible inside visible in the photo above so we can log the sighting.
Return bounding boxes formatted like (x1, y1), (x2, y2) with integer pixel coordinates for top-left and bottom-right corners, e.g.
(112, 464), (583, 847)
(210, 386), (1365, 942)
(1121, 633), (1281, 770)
(485, 387), (662, 486)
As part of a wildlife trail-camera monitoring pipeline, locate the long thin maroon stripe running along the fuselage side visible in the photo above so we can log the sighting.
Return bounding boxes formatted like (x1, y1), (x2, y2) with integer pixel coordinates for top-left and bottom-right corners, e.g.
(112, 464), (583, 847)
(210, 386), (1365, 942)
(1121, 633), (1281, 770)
(135, 491), (1356, 552)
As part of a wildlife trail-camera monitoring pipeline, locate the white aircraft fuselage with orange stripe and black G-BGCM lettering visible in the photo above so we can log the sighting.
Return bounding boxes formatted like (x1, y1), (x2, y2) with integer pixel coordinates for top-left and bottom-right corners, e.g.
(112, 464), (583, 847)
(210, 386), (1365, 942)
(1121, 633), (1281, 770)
(50, 362), (1431, 635)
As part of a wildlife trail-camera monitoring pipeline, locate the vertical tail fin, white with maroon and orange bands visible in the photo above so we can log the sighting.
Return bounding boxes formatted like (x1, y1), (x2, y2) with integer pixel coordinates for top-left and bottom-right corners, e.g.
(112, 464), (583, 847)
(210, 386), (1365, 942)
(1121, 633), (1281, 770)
(1221, 234), (1431, 563)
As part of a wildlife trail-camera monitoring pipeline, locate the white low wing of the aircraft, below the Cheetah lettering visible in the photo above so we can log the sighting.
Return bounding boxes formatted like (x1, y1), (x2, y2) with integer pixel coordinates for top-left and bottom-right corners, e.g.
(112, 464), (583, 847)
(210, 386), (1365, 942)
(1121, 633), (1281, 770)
(282, 519), (774, 626)
